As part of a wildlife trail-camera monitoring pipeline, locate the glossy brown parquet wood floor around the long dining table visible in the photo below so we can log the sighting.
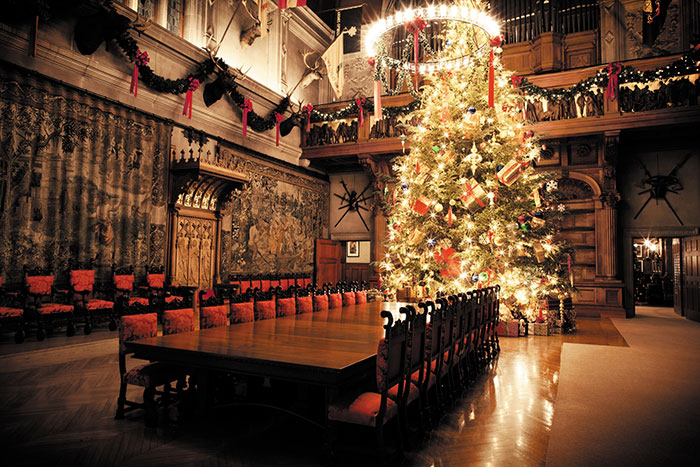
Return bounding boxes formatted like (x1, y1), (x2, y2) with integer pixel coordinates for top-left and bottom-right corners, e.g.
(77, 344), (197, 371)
(0, 319), (622, 466)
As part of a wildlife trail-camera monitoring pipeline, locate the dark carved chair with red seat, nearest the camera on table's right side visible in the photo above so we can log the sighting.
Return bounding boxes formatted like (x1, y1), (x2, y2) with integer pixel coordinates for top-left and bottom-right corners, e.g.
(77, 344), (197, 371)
(328, 311), (408, 457)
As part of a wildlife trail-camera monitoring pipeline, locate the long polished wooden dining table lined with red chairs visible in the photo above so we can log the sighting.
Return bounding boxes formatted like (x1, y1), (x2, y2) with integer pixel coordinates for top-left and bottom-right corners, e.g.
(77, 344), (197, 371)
(124, 302), (404, 426)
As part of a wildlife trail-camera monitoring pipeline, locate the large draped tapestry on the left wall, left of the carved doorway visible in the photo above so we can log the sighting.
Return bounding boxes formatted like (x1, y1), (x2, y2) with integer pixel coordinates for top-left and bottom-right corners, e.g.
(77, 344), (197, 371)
(0, 65), (170, 282)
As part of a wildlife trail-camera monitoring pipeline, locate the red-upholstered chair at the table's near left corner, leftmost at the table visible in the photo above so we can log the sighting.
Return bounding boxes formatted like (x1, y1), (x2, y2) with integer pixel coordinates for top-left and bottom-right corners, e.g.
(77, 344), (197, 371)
(114, 313), (184, 426)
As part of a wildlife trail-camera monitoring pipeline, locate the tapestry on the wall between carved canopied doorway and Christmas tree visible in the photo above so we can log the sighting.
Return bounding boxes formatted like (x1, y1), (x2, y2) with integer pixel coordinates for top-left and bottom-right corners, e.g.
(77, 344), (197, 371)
(220, 148), (329, 278)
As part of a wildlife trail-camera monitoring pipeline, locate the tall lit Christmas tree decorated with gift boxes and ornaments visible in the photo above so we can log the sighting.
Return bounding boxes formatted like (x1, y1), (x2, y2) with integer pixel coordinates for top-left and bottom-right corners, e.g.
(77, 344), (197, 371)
(378, 2), (573, 326)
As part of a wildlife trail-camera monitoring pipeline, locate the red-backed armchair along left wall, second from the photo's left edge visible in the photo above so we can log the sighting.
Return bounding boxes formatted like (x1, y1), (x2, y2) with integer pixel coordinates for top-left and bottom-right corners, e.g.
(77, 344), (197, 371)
(24, 270), (75, 341)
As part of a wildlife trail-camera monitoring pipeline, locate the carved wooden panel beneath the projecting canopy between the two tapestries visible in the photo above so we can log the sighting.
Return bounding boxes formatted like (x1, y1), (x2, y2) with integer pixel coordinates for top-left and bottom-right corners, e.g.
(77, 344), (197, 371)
(173, 216), (217, 289)
